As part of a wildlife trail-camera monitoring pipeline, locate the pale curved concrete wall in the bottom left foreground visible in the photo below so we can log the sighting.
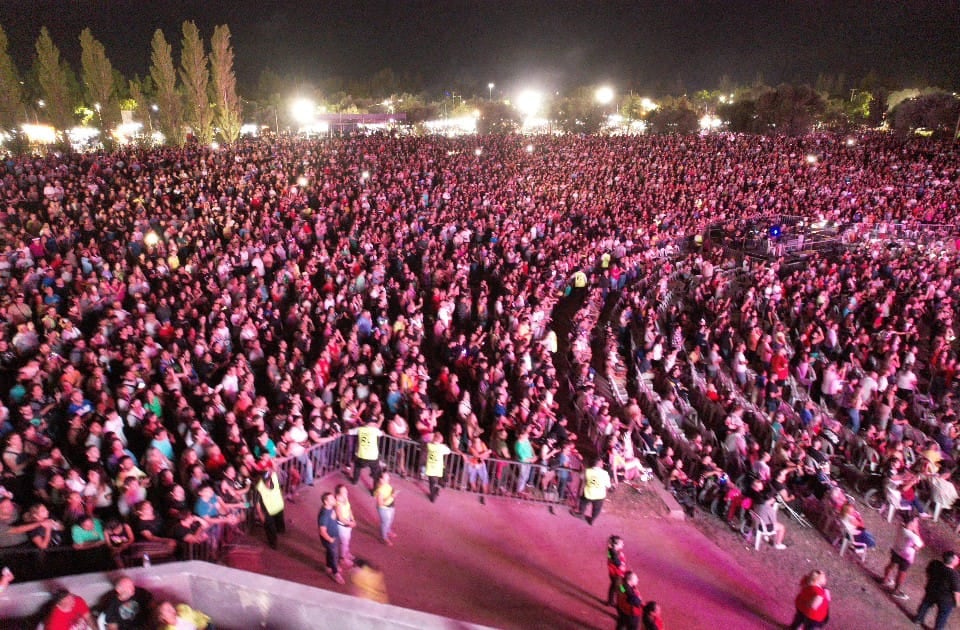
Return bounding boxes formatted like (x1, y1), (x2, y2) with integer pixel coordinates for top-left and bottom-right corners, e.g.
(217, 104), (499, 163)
(0, 562), (492, 630)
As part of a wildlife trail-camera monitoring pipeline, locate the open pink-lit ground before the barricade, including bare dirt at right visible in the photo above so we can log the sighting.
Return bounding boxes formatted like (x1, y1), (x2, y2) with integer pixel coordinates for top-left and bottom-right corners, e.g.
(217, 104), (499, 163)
(231, 476), (944, 630)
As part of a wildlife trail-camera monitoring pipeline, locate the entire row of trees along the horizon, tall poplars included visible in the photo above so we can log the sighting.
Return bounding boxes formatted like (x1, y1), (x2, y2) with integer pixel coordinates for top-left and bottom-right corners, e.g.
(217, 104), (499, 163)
(0, 21), (960, 145)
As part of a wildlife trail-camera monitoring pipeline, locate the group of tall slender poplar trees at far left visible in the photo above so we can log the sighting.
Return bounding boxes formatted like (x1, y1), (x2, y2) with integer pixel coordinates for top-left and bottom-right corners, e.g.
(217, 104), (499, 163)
(0, 20), (242, 145)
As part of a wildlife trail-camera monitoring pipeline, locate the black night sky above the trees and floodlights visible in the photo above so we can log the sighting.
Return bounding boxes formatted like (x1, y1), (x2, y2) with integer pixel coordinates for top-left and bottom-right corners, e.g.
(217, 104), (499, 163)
(0, 0), (960, 96)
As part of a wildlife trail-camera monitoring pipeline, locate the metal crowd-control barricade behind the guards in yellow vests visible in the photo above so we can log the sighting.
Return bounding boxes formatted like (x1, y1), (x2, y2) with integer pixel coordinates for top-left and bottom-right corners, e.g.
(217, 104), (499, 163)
(260, 434), (583, 516)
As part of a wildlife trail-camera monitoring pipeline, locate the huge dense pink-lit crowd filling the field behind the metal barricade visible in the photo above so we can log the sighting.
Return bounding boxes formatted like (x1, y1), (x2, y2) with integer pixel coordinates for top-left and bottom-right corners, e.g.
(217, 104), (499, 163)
(0, 135), (960, 628)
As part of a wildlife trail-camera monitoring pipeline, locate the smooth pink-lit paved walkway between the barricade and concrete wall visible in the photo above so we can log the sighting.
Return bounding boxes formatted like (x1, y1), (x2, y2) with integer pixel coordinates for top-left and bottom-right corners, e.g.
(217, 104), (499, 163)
(242, 473), (794, 629)
